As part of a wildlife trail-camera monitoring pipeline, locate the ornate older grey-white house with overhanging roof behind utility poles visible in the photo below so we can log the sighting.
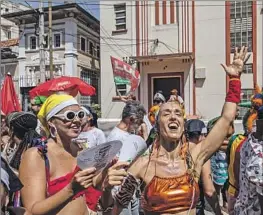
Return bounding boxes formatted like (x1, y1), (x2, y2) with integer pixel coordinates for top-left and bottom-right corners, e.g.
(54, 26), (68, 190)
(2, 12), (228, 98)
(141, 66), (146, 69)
(5, 3), (100, 109)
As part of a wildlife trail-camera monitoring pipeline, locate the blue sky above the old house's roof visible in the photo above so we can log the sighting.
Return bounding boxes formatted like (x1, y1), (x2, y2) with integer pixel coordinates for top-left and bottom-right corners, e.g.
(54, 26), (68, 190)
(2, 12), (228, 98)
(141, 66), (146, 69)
(15, 0), (100, 19)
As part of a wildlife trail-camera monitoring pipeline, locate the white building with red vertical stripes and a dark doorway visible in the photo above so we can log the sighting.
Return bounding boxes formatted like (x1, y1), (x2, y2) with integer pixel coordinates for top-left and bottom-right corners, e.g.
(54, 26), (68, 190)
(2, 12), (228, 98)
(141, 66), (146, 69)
(100, 1), (263, 119)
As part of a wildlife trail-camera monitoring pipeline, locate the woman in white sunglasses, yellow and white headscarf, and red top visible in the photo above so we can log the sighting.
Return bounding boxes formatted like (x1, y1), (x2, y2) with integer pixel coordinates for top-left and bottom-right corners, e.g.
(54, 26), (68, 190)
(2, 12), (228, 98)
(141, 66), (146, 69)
(19, 95), (99, 215)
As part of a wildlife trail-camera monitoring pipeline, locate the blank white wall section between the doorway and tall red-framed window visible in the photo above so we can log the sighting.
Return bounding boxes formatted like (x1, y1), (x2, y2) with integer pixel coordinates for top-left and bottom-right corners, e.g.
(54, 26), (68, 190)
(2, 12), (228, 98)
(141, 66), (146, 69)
(195, 1), (226, 119)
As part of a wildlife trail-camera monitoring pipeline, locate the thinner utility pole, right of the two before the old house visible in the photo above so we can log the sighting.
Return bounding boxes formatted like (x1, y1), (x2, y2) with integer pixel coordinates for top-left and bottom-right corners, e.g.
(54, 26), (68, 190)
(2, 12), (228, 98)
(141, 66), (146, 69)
(48, 0), (54, 79)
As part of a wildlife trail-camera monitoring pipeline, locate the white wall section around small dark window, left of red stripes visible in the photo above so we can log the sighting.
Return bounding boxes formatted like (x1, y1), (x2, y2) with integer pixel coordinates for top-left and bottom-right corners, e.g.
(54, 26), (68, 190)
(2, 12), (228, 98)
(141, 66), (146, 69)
(100, 1), (136, 118)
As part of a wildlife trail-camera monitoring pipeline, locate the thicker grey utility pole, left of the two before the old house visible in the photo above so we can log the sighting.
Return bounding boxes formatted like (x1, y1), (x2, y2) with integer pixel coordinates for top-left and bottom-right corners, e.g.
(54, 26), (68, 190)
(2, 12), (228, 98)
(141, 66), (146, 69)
(39, 0), (46, 83)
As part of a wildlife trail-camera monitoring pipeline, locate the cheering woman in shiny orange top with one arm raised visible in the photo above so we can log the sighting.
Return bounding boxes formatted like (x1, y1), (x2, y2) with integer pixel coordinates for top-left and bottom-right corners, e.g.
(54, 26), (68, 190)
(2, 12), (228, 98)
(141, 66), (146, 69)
(100, 47), (250, 215)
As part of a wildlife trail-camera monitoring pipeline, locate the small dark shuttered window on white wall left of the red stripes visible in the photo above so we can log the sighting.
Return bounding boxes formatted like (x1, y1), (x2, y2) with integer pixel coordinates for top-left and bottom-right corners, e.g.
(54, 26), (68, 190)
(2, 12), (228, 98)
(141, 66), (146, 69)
(114, 4), (126, 31)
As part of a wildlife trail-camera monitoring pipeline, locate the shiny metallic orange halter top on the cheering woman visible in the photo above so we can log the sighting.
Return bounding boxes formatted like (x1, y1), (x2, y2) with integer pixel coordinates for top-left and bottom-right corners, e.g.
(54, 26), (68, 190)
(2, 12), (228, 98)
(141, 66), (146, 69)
(142, 141), (200, 214)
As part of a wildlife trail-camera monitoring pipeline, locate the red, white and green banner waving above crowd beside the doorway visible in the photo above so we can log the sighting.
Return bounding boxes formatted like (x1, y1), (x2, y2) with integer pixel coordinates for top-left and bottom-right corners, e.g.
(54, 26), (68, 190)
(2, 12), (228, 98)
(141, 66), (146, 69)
(111, 57), (140, 95)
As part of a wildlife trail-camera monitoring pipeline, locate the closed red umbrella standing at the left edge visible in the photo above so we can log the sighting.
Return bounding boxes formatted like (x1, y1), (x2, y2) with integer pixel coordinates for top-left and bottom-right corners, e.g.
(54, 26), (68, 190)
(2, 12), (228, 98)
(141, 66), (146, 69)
(1, 74), (21, 115)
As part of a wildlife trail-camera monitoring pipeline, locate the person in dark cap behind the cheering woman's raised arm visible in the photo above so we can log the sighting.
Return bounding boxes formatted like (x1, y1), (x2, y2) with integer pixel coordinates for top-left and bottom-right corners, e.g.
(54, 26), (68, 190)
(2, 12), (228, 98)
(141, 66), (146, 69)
(185, 119), (222, 215)
